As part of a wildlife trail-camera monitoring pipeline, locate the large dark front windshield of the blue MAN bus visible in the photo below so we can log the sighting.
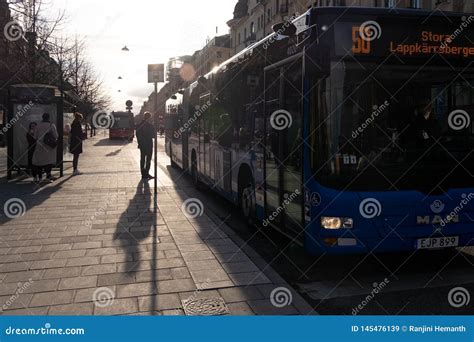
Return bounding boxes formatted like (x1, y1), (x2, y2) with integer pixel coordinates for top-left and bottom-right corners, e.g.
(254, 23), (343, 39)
(312, 62), (474, 193)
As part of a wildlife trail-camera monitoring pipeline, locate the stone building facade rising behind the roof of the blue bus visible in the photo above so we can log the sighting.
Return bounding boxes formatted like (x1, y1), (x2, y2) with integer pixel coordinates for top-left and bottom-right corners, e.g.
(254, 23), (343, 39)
(227, 0), (474, 54)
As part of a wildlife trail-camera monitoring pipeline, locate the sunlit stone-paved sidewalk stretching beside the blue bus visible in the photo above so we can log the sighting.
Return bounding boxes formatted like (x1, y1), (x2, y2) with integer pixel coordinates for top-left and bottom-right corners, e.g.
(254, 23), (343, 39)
(0, 134), (311, 315)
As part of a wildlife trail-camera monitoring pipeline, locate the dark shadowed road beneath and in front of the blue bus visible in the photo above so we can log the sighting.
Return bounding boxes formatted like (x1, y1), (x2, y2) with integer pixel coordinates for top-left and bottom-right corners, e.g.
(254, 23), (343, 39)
(152, 136), (474, 315)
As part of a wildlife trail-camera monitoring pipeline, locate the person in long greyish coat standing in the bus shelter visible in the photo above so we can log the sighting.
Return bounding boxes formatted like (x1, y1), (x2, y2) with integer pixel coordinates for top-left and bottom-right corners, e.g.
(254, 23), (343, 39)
(33, 113), (59, 183)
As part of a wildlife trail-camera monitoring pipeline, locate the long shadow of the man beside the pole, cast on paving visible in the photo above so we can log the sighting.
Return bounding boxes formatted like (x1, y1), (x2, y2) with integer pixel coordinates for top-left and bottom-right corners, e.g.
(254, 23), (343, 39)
(114, 181), (154, 276)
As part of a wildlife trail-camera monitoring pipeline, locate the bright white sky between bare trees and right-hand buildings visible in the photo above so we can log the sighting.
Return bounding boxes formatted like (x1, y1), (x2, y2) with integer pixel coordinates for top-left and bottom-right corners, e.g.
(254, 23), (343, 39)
(48, 0), (237, 112)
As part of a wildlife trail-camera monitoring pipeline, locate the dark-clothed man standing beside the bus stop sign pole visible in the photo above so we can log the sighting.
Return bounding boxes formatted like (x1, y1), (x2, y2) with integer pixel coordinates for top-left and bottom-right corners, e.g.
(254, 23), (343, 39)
(137, 112), (156, 180)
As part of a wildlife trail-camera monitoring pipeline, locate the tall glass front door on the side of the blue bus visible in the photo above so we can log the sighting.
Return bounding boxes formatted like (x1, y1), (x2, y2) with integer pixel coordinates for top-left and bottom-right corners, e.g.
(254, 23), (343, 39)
(265, 57), (304, 234)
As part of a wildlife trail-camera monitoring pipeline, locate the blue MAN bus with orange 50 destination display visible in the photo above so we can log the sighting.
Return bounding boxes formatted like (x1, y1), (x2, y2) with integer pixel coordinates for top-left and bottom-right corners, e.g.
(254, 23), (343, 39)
(171, 7), (474, 254)
